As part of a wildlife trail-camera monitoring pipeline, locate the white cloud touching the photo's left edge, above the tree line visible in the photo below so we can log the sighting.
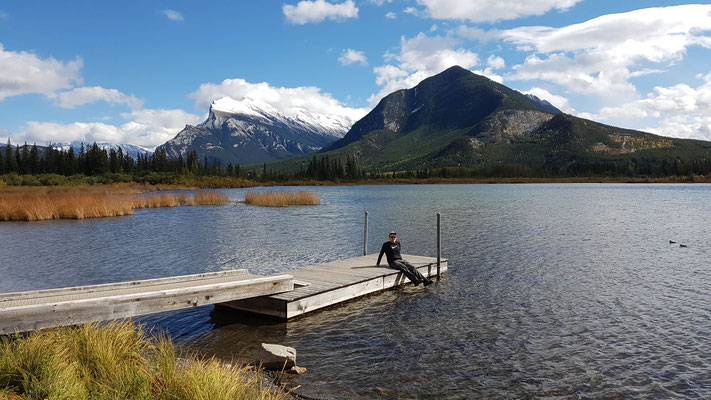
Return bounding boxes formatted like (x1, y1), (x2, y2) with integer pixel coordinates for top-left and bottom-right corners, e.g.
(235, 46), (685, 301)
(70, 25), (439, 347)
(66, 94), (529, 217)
(0, 44), (83, 100)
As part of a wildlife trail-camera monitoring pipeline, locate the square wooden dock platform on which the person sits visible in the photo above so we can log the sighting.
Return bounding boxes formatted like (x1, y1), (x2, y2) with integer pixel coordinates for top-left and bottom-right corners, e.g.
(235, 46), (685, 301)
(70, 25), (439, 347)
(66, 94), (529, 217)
(221, 254), (447, 320)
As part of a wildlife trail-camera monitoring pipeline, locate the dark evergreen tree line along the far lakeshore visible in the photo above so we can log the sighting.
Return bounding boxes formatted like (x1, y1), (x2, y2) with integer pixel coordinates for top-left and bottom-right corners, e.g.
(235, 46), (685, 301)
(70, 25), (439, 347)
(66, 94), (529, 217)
(0, 140), (711, 182)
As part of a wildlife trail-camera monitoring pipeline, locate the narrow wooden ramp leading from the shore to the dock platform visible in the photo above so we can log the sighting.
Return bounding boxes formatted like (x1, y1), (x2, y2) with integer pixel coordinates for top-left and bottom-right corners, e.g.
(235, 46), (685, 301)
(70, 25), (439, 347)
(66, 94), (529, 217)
(0, 270), (294, 334)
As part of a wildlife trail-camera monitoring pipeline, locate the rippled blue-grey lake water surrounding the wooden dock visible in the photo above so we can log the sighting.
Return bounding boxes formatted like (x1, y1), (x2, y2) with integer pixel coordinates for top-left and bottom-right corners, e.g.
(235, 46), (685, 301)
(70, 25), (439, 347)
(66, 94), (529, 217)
(0, 184), (711, 399)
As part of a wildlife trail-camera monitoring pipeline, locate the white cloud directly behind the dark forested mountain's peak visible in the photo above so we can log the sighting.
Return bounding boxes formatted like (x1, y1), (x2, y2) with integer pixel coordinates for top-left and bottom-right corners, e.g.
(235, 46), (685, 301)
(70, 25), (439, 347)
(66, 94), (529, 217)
(368, 33), (479, 105)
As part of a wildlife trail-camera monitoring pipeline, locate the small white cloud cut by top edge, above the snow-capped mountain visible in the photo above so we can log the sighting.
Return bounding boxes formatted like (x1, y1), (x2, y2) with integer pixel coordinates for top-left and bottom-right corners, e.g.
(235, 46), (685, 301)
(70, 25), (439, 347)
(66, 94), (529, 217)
(282, 0), (358, 25)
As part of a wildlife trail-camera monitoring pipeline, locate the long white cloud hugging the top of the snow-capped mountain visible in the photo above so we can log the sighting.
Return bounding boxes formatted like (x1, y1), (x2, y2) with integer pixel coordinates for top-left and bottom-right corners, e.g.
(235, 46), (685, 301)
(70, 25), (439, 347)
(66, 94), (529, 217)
(188, 78), (369, 121)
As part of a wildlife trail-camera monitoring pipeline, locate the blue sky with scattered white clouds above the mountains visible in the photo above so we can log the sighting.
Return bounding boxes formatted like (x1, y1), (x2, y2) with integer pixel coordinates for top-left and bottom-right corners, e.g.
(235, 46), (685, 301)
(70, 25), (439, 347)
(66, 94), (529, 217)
(0, 0), (711, 148)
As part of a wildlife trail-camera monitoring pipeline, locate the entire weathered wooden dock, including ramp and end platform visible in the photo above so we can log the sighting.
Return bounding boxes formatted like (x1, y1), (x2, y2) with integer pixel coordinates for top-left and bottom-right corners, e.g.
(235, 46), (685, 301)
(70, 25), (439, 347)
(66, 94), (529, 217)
(0, 254), (447, 335)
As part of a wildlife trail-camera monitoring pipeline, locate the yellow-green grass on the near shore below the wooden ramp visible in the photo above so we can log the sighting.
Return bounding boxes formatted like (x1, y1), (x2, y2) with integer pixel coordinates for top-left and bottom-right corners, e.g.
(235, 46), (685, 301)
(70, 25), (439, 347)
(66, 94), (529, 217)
(0, 321), (287, 400)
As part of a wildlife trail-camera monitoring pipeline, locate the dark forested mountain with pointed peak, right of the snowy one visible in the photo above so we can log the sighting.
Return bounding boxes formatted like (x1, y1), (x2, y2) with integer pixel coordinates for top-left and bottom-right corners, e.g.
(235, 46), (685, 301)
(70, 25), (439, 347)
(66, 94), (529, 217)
(260, 66), (711, 175)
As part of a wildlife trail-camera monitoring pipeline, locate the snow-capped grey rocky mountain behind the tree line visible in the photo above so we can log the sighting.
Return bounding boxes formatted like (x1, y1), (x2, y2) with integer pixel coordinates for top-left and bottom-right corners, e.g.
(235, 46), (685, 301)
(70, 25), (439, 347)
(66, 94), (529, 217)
(156, 97), (354, 166)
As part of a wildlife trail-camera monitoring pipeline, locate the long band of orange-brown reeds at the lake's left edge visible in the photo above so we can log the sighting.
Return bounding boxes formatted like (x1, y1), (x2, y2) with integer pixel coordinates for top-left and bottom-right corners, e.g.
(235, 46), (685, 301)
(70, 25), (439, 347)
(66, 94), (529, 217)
(0, 184), (228, 221)
